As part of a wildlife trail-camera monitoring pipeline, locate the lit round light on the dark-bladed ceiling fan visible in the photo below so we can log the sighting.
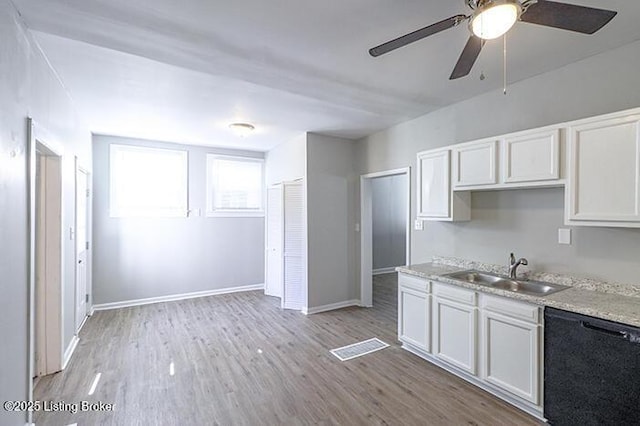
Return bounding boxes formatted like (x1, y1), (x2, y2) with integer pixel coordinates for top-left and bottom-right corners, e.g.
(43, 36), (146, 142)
(469, 0), (522, 40)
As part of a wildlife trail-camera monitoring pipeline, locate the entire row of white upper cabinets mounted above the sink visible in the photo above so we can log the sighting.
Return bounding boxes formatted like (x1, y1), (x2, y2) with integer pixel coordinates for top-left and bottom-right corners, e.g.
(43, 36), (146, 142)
(410, 108), (640, 228)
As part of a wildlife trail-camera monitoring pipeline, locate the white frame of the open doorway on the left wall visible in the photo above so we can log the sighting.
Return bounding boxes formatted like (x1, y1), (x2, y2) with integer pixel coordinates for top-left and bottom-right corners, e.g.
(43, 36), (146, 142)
(27, 117), (65, 423)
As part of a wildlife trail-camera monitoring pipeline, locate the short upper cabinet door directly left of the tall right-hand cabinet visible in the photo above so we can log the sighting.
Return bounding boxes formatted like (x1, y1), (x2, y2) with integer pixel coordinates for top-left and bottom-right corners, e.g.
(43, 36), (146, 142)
(502, 129), (560, 183)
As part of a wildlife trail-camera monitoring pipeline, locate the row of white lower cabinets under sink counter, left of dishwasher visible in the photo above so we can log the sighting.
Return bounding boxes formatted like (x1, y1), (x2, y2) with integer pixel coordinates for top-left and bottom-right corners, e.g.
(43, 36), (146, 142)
(398, 274), (543, 418)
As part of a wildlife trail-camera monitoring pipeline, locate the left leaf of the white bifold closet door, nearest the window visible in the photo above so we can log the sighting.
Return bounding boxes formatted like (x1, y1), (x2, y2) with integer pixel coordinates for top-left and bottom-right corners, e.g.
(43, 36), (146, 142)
(264, 185), (283, 297)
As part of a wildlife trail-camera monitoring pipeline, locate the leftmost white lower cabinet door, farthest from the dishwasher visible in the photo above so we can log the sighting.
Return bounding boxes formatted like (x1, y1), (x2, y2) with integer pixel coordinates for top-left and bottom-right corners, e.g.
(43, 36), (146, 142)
(398, 285), (431, 352)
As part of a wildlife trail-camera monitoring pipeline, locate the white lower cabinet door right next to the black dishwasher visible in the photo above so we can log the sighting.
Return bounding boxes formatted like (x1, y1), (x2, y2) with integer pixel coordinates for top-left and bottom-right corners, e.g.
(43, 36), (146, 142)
(482, 310), (540, 405)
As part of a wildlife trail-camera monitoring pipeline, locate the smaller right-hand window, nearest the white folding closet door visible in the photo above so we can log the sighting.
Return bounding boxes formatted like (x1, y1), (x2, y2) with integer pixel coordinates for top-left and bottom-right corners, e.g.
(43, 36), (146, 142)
(207, 154), (264, 216)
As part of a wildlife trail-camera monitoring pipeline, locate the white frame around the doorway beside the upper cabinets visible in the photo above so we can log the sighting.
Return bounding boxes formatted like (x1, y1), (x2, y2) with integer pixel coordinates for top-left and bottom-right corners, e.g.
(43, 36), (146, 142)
(360, 167), (411, 308)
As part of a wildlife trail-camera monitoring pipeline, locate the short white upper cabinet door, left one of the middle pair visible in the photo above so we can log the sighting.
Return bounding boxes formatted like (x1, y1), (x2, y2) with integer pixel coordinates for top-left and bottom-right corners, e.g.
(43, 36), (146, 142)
(453, 140), (498, 188)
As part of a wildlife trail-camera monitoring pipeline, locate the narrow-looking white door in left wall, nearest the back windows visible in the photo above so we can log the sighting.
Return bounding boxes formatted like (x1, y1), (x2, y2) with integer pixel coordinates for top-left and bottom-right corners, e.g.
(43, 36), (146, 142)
(75, 168), (89, 330)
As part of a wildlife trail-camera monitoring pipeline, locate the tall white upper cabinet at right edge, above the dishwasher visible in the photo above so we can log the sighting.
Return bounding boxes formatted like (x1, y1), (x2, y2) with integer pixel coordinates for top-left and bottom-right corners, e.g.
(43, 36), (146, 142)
(565, 110), (640, 227)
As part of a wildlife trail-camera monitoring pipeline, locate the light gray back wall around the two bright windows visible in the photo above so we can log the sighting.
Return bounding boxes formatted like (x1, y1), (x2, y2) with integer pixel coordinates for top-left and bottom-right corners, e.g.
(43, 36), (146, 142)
(93, 136), (264, 304)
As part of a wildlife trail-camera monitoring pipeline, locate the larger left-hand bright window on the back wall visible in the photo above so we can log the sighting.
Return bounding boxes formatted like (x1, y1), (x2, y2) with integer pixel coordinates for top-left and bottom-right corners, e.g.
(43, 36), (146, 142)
(110, 145), (188, 217)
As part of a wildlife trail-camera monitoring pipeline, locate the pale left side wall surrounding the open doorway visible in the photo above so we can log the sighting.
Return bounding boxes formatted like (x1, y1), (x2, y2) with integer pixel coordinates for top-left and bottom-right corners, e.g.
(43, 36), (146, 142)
(0, 0), (91, 426)
